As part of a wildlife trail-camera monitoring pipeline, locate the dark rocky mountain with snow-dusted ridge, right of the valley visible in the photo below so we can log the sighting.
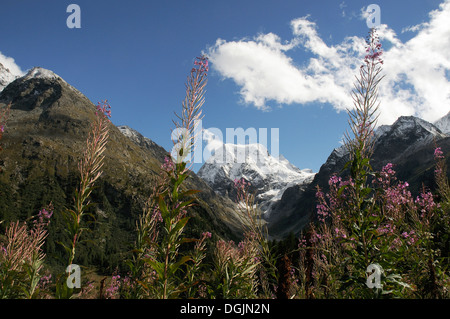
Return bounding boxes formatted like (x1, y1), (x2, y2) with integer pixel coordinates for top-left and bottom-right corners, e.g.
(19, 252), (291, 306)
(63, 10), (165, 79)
(269, 115), (450, 238)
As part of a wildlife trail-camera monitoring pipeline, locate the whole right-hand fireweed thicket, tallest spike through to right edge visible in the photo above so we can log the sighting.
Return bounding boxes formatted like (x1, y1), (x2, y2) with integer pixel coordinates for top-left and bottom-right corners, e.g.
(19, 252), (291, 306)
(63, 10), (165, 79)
(299, 30), (449, 298)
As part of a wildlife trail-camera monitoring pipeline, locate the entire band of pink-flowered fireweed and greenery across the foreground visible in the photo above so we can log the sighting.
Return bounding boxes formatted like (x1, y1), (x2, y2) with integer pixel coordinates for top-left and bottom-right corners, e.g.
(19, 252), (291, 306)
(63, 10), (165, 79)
(0, 29), (450, 299)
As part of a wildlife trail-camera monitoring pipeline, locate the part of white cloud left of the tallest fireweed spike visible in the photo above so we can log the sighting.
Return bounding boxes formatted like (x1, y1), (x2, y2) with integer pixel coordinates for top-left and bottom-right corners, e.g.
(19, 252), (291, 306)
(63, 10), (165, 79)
(209, 17), (360, 110)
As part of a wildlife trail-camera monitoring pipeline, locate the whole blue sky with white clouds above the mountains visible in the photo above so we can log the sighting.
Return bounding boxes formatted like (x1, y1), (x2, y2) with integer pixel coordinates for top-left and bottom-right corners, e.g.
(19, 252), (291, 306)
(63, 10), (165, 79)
(0, 0), (450, 171)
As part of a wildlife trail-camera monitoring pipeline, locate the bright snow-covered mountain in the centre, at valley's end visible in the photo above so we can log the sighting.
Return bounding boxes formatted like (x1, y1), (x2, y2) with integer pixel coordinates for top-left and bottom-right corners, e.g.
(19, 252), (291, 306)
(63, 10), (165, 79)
(197, 144), (314, 219)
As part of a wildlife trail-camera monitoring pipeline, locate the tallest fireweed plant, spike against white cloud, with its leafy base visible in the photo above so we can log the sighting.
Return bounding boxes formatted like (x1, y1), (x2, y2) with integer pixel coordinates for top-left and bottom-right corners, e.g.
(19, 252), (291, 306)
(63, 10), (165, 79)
(303, 29), (410, 297)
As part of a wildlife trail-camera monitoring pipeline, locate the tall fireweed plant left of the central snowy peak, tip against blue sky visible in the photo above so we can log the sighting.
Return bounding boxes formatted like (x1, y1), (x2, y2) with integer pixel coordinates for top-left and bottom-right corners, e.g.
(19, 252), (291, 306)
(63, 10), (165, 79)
(128, 56), (208, 299)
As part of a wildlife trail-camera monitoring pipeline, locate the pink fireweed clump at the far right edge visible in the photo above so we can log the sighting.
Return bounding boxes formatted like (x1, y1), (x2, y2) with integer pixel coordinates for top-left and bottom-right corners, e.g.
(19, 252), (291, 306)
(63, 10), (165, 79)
(405, 147), (450, 298)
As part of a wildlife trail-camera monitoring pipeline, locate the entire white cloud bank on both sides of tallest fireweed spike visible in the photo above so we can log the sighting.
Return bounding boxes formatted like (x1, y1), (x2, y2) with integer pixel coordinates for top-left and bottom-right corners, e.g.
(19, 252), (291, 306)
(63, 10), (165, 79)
(208, 0), (450, 124)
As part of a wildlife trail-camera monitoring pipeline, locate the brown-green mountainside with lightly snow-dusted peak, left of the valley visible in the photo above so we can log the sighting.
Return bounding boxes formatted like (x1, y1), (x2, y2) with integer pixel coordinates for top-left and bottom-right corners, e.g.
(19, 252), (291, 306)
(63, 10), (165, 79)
(0, 68), (243, 271)
